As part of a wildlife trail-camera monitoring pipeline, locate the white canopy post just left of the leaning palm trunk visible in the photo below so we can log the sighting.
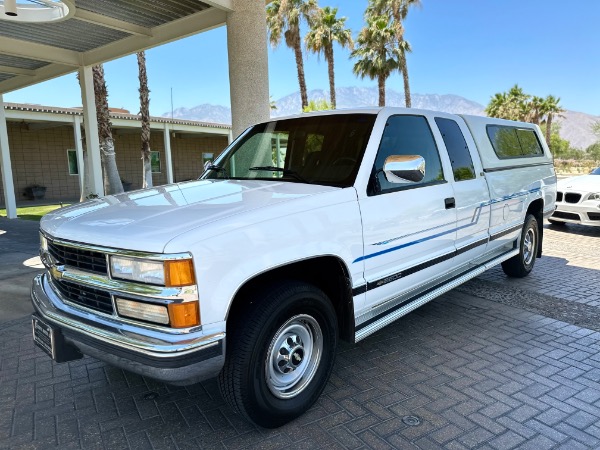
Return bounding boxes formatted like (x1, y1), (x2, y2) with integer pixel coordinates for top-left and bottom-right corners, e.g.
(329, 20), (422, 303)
(79, 66), (104, 197)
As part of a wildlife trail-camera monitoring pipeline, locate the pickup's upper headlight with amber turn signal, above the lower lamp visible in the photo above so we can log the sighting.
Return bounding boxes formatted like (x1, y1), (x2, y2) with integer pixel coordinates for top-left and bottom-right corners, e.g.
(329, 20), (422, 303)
(110, 256), (196, 287)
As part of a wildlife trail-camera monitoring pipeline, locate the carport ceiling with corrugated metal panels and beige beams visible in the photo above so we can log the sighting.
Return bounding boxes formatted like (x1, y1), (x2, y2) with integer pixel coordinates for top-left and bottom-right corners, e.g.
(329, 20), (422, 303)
(0, 0), (232, 93)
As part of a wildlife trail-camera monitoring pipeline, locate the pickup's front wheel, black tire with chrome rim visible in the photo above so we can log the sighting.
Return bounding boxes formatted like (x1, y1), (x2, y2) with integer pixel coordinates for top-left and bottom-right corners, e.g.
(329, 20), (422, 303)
(218, 281), (337, 428)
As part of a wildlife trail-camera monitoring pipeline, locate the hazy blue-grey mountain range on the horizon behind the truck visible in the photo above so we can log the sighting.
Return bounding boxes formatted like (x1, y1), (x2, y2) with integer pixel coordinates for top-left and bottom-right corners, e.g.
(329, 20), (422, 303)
(162, 87), (600, 149)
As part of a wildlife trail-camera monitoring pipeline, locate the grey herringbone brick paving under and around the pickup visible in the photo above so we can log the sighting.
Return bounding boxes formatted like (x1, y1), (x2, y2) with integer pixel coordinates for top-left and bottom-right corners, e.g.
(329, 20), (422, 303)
(0, 217), (600, 450)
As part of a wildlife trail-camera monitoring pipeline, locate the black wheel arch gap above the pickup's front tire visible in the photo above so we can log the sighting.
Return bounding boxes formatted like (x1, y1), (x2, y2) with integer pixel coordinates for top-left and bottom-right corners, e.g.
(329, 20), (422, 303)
(226, 255), (355, 342)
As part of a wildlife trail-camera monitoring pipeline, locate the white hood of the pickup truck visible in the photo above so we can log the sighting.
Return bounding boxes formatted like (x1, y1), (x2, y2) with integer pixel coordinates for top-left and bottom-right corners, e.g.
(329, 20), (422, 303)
(40, 180), (338, 253)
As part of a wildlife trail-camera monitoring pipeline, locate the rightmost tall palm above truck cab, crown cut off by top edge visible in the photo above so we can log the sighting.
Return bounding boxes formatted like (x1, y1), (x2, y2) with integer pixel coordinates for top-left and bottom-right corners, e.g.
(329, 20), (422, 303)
(367, 0), (421, 108)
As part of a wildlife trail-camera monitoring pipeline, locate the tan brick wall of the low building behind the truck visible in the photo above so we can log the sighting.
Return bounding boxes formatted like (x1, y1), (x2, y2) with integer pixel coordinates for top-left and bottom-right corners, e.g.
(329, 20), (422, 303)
(0, 122), (227, 206)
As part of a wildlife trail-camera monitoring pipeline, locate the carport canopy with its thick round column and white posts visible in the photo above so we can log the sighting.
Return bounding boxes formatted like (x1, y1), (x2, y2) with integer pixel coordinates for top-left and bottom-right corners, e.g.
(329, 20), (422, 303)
(0, 0), (269, 218)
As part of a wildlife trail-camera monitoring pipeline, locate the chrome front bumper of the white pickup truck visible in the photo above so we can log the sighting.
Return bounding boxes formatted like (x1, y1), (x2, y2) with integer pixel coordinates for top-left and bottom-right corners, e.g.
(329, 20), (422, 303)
(31, 274), (225, 385)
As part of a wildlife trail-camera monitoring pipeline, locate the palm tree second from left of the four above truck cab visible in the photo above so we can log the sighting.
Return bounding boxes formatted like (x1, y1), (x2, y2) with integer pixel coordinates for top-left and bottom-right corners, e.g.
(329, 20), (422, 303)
(304, 6), (354, 109)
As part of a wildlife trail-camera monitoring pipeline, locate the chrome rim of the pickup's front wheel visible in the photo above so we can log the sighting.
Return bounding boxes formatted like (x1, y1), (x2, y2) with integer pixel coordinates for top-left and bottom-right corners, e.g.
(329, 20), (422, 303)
(265, 314), (323, 399)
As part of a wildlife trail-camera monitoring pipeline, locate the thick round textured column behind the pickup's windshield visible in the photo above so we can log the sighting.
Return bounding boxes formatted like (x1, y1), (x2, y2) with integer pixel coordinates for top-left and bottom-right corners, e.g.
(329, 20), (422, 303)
(227, 0), (271, 137)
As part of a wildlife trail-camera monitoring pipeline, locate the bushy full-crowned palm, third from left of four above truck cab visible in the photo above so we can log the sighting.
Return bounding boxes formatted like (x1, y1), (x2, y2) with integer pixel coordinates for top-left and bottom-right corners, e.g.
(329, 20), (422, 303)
(350, 16), (400, 106)
